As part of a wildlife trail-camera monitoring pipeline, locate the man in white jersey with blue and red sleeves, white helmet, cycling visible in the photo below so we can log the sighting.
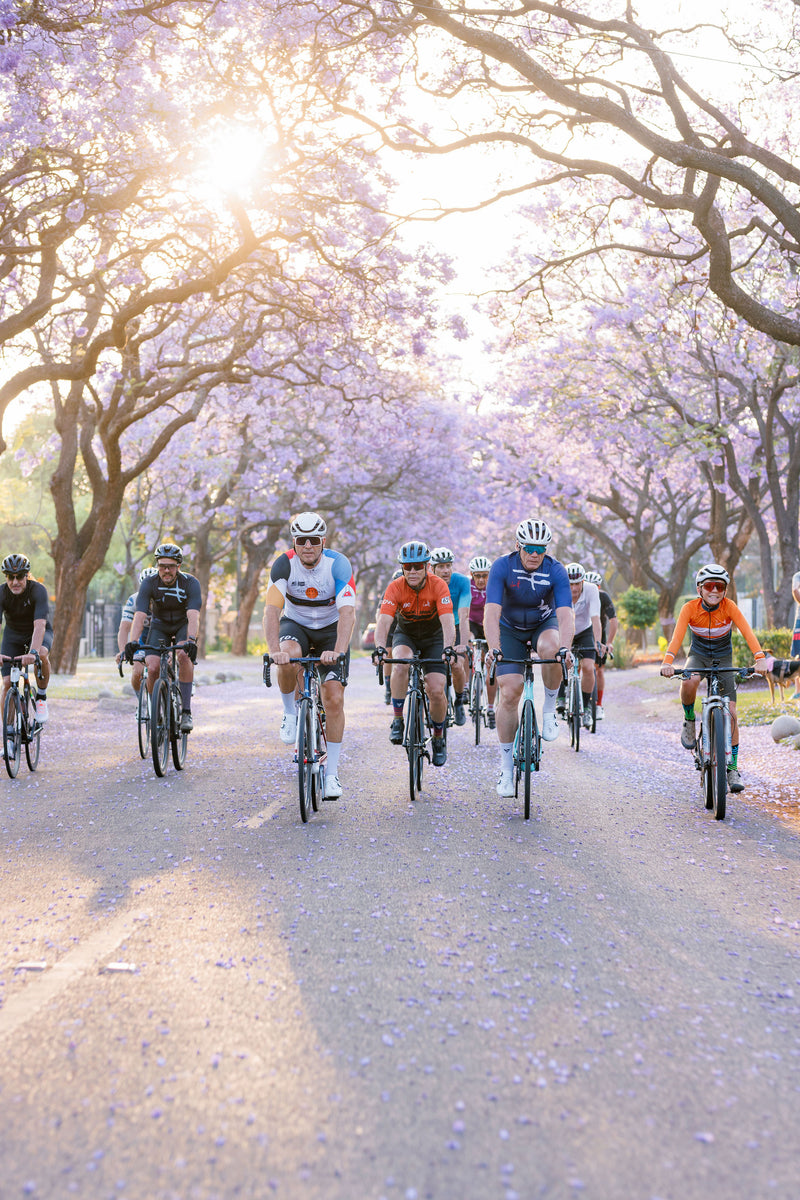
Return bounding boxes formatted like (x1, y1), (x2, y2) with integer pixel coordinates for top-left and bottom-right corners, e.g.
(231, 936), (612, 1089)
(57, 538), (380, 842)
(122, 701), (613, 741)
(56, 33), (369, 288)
(264, 512), (355, 800)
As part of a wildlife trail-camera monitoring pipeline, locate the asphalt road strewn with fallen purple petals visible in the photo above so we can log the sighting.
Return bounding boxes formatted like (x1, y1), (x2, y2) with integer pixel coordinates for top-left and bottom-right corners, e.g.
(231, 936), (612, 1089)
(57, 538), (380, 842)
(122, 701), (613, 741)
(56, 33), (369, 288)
(0, 660), (800, 1200)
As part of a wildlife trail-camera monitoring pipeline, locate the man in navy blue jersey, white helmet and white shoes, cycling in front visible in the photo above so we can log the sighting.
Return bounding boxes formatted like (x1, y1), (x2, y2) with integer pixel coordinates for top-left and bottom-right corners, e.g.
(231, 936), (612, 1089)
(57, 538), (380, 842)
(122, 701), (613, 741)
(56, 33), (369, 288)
(483, 518), (575, 796)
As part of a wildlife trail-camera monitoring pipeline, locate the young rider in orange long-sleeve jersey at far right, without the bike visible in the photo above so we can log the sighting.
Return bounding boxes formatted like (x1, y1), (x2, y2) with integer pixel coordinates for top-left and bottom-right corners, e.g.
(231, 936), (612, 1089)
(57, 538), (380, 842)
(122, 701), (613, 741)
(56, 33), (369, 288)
(661, 563), (768, 792)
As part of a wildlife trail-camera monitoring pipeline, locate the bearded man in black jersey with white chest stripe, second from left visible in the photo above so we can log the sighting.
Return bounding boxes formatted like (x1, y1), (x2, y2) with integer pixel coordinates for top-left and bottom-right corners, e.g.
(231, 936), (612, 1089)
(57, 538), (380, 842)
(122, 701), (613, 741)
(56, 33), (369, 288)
(125, 541), (203, 733)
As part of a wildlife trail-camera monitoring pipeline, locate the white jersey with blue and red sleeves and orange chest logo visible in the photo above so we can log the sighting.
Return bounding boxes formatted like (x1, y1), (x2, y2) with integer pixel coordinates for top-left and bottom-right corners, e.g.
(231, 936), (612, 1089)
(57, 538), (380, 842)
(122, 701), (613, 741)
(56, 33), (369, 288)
(266, 548), (355, 629)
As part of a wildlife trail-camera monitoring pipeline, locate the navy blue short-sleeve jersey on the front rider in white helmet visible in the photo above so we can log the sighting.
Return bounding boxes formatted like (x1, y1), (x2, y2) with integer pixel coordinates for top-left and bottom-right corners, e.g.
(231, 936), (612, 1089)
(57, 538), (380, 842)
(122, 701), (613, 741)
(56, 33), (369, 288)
(486, 551), (572, 632)
